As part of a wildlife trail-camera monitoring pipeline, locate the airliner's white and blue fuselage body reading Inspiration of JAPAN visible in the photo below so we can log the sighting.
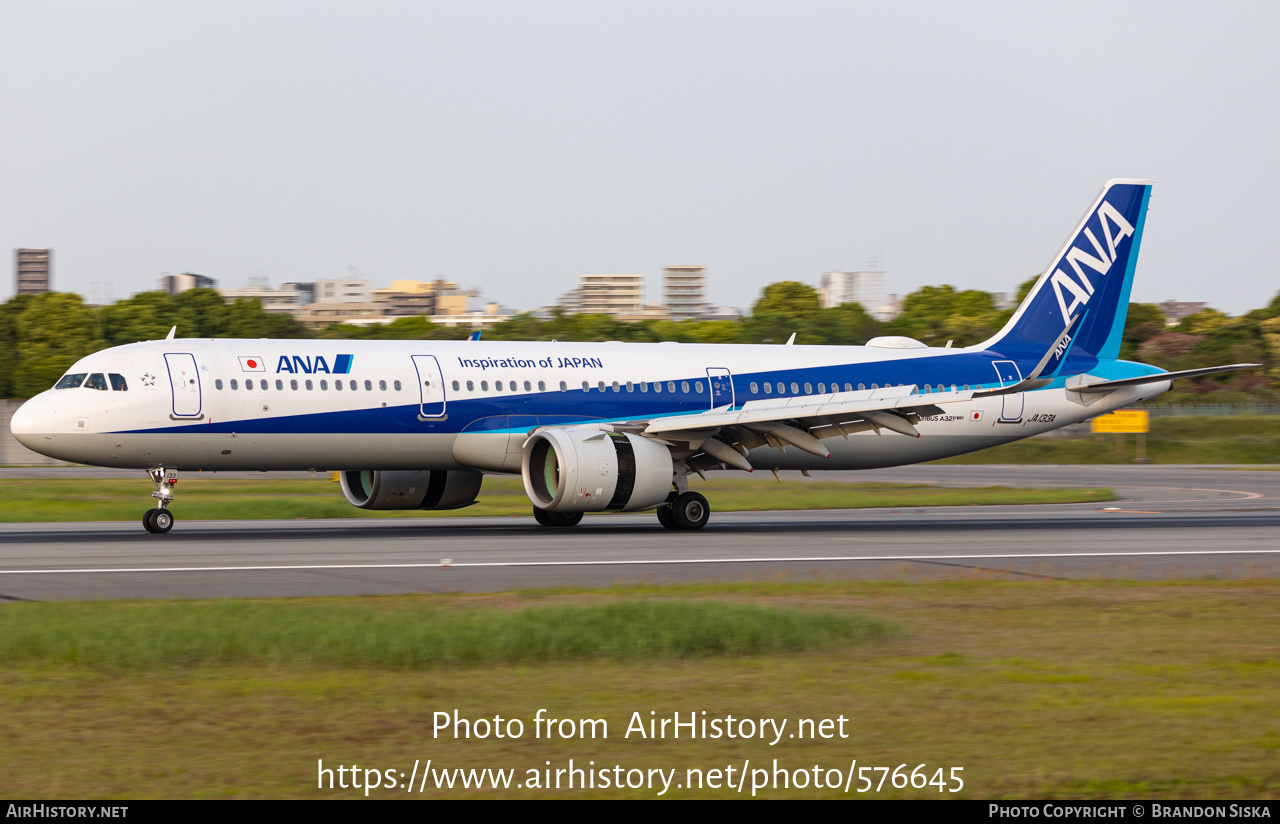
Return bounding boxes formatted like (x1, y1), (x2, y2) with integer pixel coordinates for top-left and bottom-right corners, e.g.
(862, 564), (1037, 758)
(13, 339), (1169, 473)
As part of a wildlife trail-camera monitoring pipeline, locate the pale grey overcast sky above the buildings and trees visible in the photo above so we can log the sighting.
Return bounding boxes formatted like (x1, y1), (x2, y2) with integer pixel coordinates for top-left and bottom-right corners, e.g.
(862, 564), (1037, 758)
(0, 0), (1280, 313)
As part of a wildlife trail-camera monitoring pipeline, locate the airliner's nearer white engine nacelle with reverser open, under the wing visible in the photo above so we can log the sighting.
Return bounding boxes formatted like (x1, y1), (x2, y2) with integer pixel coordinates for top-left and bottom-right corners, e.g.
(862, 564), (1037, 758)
(521, 427), (672, 512)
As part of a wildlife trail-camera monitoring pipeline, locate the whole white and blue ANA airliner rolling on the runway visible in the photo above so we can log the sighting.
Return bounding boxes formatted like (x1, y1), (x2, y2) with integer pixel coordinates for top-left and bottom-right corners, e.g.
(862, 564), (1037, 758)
(12, 180), (1252, 532)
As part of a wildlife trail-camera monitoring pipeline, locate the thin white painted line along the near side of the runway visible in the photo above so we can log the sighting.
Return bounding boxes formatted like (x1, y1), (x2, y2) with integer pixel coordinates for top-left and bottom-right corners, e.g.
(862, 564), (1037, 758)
(0, 549), (1280, 574)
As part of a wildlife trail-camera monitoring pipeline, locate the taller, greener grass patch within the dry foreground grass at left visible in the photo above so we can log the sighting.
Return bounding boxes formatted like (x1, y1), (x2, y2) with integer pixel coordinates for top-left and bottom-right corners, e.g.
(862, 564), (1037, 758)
(0, 600), (893, 669)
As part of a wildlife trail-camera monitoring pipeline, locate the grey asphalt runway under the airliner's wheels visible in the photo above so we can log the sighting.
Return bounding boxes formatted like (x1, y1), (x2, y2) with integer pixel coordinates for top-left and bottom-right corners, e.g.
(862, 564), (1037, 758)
(0, 466), (1280, 600)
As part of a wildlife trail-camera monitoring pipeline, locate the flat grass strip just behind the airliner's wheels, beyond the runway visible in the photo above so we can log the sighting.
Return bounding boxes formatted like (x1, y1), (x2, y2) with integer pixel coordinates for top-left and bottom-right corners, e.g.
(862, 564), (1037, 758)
(0, 473), (1115, 523)
